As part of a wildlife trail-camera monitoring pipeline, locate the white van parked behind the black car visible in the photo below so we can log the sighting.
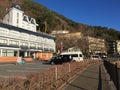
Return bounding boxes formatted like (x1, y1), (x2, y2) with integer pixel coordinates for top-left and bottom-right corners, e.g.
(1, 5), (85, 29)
(61, 51), (83, 61)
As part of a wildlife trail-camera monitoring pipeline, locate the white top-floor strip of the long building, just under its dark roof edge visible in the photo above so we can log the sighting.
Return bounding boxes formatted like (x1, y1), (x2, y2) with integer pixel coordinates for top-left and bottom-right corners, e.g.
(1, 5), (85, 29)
(0, 28), (54, 44)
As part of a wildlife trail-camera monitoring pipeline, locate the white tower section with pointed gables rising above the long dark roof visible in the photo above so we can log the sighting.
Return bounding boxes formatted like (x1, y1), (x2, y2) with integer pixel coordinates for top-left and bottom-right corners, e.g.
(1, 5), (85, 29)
(3, 4), (38, 32)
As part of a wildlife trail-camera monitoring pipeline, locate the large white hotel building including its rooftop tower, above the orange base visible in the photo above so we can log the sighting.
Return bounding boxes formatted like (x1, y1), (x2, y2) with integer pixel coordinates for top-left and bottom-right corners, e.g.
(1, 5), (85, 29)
(0, 4), (55, 57)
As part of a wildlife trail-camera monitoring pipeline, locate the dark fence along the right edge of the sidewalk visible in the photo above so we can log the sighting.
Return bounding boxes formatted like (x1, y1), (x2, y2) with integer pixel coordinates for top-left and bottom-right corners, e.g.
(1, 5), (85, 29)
(104, 60), (120, 90)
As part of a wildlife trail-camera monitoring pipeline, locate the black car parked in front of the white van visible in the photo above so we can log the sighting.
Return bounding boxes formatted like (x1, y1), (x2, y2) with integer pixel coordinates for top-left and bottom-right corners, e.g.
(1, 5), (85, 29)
(49, 55), (71, 64)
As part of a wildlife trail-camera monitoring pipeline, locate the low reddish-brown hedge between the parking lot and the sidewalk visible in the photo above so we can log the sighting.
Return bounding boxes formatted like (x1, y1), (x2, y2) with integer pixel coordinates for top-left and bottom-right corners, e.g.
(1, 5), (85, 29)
(0, 60), (100, 90)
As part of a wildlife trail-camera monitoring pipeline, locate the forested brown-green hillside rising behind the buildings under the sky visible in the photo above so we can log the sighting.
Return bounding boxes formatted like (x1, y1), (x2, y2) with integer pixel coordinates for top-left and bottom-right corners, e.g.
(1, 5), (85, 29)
(0, 0), (120, 41)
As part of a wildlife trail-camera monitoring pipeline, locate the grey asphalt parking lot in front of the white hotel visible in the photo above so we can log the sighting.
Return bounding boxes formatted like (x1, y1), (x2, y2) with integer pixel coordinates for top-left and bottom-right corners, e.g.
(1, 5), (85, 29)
(0, 62), (52, 78)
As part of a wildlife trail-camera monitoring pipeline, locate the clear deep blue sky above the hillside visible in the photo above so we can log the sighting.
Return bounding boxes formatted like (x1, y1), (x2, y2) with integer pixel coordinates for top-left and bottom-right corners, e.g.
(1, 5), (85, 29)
(34, 0), (120, 31)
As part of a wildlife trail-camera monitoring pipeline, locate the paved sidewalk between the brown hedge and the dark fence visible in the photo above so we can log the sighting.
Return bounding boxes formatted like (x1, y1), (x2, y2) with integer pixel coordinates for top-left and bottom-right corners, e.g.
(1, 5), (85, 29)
(63, 64), (113, 90)
